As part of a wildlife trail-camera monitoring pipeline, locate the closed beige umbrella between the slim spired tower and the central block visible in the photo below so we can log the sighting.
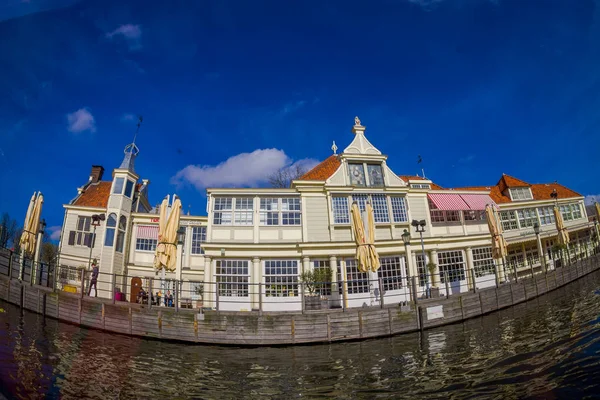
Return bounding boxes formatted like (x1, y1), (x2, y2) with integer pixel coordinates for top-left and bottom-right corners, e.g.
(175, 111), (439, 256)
(154, 198), (181, 272)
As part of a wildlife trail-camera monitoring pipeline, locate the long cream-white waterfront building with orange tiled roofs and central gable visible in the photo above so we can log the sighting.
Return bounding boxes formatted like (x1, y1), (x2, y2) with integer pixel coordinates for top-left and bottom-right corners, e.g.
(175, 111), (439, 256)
(60, 120), (593, 311)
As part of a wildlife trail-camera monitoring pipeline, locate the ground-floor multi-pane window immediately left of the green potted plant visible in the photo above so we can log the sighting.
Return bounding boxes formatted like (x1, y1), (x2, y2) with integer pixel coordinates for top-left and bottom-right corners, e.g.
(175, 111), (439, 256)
(265, 260), (298, 297)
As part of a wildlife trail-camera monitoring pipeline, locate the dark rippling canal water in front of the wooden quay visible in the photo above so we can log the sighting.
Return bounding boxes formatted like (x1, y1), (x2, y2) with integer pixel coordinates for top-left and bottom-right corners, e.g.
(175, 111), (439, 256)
(0, 272), (600, 399)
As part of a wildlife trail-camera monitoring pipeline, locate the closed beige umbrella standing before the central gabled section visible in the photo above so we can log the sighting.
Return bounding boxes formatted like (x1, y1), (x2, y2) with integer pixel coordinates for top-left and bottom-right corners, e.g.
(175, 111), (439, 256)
(351, 203), (380, 272)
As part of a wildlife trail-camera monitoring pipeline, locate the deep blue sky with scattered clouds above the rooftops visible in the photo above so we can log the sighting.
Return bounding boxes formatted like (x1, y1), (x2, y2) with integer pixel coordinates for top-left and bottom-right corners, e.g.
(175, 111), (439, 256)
(0, 0), (600, 241)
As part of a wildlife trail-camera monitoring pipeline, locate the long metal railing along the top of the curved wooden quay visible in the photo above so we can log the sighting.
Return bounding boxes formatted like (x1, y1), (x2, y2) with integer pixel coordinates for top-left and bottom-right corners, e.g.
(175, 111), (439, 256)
(0, 243), (600, 312)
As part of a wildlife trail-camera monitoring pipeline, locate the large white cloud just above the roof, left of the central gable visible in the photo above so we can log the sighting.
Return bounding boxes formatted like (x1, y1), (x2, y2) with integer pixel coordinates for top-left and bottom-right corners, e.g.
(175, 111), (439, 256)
(171, 149), (318, 190)
